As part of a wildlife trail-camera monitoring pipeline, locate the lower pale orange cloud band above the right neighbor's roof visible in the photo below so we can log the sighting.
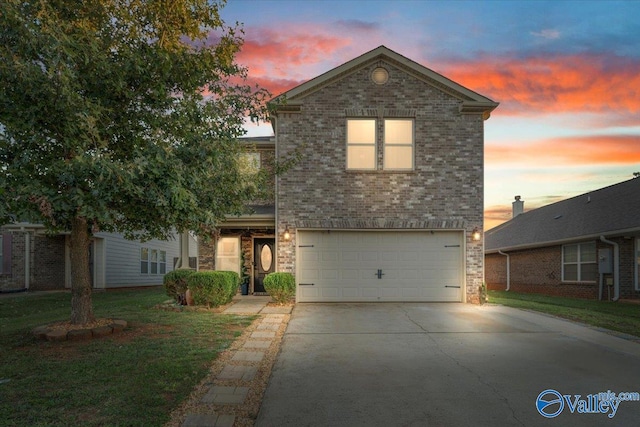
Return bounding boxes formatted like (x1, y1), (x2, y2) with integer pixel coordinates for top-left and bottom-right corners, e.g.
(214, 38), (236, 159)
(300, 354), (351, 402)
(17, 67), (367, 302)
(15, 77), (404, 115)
(485, 135), (640, 166)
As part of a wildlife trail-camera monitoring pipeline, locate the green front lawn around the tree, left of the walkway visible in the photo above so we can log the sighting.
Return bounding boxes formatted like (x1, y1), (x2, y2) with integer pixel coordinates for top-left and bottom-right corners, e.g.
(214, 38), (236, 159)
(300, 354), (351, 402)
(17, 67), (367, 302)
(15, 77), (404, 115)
(0, 288), (254, 426)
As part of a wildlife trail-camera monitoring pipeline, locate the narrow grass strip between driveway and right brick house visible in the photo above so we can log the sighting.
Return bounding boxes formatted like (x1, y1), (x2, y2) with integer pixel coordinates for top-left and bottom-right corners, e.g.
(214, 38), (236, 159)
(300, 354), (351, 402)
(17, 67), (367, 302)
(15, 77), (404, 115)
(489, 291), (640, 337)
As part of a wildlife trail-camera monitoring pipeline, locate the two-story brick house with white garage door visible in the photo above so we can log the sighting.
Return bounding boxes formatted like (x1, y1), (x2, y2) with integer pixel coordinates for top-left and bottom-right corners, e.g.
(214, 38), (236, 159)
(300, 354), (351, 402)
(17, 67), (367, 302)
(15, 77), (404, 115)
(206, 46), (498, 302)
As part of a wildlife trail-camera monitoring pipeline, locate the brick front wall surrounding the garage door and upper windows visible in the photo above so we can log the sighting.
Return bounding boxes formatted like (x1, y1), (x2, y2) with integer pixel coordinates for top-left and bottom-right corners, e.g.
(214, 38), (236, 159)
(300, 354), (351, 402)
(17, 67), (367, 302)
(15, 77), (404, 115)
(276, 60), (484, 302)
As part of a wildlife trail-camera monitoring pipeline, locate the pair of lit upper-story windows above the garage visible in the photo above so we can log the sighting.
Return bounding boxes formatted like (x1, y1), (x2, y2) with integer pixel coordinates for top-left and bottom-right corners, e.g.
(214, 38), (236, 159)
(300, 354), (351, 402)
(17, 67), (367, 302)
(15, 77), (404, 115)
(347, 119), (414, 171)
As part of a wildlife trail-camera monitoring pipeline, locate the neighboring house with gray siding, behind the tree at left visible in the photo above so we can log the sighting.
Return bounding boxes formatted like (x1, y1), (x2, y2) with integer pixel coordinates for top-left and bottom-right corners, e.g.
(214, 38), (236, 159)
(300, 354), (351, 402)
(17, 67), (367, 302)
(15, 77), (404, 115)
(0, 223), (198, 292)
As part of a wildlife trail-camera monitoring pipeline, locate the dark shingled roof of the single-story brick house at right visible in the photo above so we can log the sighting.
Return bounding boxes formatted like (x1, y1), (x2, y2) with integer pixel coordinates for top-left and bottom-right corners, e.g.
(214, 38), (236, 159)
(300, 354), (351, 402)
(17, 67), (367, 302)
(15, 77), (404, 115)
(485, 178), (640, 253)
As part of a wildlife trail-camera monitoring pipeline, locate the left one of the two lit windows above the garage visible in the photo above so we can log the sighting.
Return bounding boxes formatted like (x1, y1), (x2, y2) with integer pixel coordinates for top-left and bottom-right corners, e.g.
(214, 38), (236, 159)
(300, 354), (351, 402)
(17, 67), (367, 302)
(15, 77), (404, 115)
(347, 119), (377, 170)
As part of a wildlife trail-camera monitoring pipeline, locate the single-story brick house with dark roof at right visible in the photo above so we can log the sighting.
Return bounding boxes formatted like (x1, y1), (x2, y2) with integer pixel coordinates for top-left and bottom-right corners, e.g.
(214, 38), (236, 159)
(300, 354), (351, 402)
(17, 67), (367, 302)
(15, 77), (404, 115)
(485, 179), (640, 300)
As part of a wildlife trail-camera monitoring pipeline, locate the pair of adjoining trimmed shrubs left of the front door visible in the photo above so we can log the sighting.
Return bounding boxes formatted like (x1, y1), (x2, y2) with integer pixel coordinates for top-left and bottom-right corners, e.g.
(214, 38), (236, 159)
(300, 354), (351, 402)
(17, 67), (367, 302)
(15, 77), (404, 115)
(164, 270), (240, 307)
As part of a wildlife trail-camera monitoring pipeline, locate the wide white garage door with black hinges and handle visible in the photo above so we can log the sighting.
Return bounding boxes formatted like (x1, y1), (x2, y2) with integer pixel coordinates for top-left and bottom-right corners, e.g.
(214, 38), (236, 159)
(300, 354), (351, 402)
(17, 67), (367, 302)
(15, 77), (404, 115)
(296, 231), (464, 302)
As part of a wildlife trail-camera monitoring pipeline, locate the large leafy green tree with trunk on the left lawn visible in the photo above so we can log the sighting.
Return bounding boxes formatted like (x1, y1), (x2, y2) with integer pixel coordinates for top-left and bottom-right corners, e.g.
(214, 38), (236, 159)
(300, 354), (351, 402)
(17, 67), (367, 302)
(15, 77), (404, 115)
(0, 0), (267, 324)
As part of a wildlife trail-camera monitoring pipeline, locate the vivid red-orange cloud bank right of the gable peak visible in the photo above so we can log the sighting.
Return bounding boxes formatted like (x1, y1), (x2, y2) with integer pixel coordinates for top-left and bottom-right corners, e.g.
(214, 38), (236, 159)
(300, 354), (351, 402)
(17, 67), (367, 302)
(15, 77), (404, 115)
(443, 54), (640, 114)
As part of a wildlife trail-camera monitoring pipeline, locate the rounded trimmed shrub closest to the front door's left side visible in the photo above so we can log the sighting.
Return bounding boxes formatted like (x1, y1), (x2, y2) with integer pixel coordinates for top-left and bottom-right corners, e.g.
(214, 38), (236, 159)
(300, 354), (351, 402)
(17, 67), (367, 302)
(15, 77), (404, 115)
(187, 271), (240, 307)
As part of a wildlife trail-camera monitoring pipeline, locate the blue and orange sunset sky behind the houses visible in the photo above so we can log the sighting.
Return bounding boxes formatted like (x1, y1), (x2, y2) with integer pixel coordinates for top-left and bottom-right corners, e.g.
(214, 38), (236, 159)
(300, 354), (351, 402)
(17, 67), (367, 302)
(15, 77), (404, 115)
(222, 0), (640, 229)
